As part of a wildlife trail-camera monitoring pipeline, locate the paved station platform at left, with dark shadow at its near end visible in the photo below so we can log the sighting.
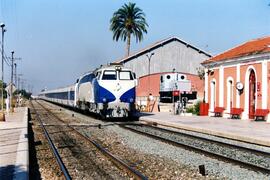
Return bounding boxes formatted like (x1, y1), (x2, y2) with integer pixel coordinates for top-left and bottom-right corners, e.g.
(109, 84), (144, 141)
(0, 107), (29, 179)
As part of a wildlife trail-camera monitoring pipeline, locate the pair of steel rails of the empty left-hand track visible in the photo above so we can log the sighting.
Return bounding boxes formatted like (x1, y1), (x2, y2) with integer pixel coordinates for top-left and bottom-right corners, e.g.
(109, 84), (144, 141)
(31, 101), (148, 180)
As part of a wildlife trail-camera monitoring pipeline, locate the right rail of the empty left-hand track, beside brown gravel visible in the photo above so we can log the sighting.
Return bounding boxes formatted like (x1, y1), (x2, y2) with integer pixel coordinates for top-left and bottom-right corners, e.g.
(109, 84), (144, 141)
(36, 101), (148, 180)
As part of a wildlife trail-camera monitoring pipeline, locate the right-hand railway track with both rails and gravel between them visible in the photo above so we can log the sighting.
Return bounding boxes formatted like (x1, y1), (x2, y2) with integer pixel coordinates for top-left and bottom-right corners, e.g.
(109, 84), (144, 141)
(120, 124), (270, 174)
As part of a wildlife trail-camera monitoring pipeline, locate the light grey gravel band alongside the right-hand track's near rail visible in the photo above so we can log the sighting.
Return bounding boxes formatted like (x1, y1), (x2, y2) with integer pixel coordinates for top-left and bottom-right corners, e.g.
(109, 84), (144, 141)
(111, 127), (270, 179)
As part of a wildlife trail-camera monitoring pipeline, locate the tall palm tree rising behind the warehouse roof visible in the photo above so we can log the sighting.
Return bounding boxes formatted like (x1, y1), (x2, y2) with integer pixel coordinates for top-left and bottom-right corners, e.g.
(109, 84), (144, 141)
(110, 2), (148, 56)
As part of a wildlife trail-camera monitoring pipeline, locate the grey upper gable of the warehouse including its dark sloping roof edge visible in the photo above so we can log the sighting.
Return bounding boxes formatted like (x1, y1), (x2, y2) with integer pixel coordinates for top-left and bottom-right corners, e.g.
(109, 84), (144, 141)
(117, 37), (211, 77)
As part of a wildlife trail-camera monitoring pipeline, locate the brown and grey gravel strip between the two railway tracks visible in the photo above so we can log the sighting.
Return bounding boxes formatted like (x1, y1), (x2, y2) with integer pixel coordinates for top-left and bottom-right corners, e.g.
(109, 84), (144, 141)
(38, 100), (270, 179)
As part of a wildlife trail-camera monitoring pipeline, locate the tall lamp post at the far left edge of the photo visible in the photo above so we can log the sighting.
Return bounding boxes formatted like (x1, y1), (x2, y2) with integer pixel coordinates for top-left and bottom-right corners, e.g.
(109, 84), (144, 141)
(0, 23), (6, 121)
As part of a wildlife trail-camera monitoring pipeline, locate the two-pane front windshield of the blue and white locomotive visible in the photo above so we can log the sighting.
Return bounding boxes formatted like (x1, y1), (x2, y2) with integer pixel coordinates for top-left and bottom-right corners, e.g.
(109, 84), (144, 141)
(102, 70), (134, 80)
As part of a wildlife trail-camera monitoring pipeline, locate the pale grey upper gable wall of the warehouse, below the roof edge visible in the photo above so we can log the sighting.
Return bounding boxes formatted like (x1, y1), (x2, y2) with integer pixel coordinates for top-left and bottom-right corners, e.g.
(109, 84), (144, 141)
(124, 40), (209, 77)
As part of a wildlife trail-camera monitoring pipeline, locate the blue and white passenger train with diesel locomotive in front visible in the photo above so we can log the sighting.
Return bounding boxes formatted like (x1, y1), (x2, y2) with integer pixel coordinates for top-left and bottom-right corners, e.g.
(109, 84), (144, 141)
(38, 63), (138, 118)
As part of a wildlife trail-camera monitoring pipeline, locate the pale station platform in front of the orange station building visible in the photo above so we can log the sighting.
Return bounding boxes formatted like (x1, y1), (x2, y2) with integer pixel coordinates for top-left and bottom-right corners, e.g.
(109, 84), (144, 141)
(139, 112), (270, 147)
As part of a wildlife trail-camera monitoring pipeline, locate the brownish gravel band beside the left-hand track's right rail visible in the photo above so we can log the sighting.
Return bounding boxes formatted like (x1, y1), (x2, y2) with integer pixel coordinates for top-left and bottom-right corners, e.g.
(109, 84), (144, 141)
(76, 125), (215, 179)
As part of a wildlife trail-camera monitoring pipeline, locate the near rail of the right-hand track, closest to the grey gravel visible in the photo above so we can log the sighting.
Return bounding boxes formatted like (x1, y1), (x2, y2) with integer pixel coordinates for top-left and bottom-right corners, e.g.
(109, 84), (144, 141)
(119, 125), (270, 174)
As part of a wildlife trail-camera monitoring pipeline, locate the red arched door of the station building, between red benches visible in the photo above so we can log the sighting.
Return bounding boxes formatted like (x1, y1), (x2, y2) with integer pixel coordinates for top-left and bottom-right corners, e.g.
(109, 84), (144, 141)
(249, 70), (256, 119)
